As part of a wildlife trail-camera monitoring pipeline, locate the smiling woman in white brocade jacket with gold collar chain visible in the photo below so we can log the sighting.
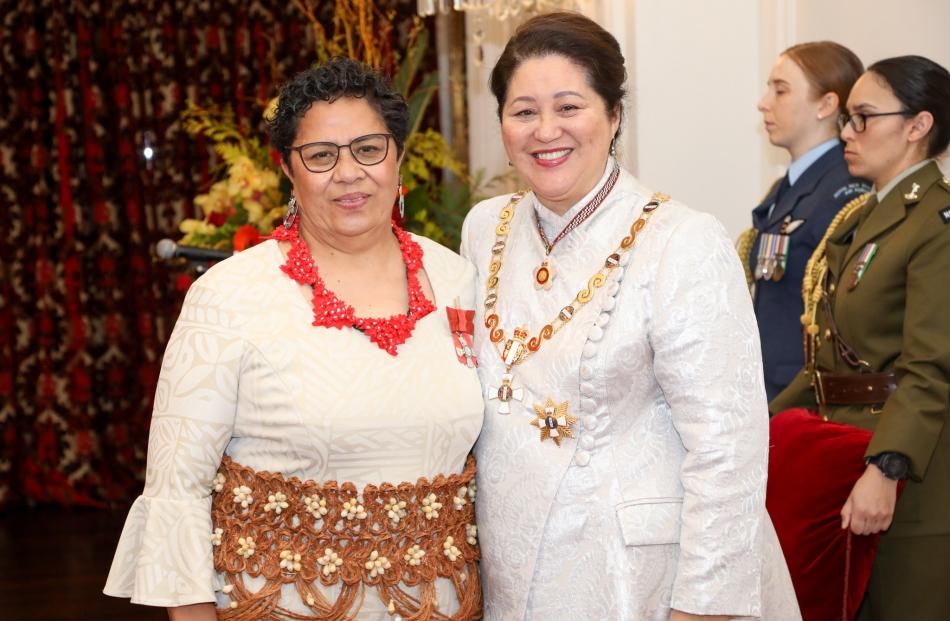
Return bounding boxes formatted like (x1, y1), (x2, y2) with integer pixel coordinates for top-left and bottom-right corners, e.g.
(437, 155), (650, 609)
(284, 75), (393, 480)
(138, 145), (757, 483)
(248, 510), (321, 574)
(462, 13), (800, 621)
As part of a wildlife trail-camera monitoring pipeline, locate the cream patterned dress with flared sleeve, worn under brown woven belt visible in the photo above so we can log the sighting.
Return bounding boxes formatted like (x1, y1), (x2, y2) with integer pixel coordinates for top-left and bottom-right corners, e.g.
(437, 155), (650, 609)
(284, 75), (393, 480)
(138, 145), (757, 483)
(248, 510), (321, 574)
(104, 236), (484, 619)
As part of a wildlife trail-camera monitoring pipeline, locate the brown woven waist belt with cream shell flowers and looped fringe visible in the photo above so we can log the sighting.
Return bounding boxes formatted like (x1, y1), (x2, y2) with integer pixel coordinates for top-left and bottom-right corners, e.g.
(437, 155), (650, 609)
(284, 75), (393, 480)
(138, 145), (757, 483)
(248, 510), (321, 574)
(211, 457), (482, 621)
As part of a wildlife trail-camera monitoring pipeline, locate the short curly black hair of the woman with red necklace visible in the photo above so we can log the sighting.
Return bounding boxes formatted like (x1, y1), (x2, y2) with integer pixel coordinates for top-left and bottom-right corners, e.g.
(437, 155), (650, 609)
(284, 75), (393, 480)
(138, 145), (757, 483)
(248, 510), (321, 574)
(267, 57), (409, 165)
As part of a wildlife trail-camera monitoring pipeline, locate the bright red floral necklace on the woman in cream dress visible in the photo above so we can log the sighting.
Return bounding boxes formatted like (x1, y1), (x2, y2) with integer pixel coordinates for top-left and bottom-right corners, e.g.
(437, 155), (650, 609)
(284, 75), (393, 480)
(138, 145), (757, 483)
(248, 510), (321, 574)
(273, 221), (435, 356)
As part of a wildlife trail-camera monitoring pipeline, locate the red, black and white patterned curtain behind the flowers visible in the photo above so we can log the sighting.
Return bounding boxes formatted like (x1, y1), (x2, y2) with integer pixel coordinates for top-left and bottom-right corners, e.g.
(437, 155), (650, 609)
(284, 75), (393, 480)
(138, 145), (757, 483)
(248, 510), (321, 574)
(0, 0), (414, 506)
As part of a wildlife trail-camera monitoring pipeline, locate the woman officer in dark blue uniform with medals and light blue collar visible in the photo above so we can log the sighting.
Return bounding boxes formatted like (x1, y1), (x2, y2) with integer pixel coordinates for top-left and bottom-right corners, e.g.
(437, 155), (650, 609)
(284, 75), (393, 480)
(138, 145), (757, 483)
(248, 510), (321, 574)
(739, 41), (871, 399)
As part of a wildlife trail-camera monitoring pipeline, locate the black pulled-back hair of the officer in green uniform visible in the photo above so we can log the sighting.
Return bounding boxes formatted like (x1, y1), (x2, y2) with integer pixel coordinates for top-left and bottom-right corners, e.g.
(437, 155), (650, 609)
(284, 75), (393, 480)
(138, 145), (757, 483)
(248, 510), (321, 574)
(868, 56), (950, 157)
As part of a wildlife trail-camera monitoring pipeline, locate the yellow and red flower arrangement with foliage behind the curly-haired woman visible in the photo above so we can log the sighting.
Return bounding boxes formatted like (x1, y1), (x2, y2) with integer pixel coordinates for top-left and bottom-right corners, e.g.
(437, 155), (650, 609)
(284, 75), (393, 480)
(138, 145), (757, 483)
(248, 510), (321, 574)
(179, 0), (472, 250)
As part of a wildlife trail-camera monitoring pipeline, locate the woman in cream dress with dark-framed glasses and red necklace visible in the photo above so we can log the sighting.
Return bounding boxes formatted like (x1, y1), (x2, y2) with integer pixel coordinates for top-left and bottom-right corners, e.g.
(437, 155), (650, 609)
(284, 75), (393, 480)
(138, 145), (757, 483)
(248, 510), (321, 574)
(105, 59), (484, 621)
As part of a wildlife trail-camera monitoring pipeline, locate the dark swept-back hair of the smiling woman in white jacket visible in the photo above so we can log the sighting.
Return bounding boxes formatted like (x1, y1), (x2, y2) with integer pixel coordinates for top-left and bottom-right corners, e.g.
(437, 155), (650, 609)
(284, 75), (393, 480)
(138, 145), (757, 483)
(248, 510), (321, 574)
(489, 11), (627, 138)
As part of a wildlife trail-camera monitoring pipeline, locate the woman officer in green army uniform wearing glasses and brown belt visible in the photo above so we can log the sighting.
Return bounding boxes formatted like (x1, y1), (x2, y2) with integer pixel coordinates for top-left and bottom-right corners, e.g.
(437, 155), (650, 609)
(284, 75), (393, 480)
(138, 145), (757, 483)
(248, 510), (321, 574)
(770, 56), (950, 621)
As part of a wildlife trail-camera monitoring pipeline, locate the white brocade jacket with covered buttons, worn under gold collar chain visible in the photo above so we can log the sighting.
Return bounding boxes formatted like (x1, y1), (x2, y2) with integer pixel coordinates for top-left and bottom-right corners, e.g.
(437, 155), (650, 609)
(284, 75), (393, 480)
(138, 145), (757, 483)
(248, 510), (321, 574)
(462, 166), (801, 621)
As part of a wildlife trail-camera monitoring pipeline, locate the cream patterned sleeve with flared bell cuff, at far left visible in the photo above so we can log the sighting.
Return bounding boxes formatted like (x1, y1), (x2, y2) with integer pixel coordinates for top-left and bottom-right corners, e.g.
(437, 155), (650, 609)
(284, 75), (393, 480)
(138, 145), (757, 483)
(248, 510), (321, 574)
(103, 282), (244, 607)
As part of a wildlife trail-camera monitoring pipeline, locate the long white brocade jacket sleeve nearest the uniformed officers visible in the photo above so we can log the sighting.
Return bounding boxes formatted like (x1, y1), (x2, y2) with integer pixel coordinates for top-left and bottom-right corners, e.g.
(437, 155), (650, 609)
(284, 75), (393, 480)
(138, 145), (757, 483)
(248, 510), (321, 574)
(649, 213), (768, 617)
